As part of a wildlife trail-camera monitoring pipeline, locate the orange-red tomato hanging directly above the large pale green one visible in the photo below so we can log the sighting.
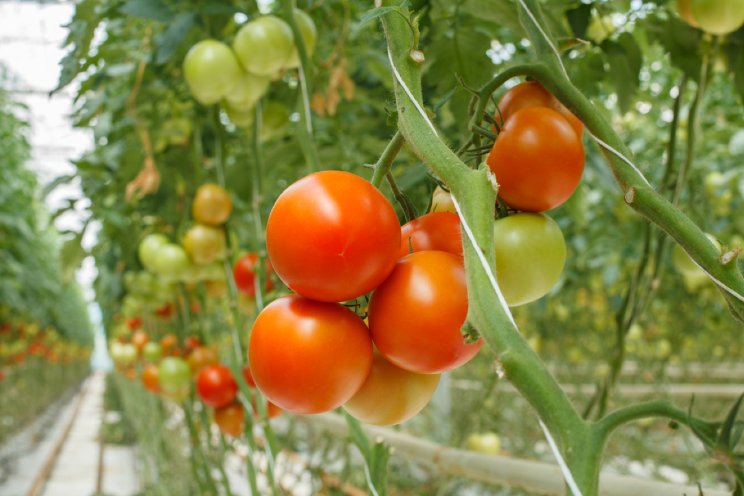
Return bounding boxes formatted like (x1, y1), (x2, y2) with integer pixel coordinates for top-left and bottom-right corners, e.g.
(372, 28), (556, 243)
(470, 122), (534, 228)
(486, 107), (584, 212)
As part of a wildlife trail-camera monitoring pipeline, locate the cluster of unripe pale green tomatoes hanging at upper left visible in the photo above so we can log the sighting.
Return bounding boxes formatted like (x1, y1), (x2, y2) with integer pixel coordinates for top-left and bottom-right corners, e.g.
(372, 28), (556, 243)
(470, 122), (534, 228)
(183, 9), (317, 126)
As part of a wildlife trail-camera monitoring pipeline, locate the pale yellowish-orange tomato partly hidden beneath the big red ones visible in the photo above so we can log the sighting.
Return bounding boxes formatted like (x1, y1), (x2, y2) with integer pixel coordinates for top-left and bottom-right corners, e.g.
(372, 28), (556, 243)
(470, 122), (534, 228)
(344, 353), (439, 425)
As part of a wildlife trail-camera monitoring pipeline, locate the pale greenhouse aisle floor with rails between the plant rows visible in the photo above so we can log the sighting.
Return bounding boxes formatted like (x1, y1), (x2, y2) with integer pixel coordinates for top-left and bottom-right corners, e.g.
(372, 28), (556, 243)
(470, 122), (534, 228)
(0, 373), (139, 496)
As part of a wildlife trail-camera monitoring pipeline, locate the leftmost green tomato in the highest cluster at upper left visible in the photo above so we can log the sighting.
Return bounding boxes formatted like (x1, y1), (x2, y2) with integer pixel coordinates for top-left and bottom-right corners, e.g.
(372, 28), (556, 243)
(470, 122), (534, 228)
(183, 40), (243, 105)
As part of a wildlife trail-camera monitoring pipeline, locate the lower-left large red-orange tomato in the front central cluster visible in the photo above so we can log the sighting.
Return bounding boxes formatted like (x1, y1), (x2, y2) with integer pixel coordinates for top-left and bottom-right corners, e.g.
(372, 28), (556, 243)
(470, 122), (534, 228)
(248, 295), (372, 413)
